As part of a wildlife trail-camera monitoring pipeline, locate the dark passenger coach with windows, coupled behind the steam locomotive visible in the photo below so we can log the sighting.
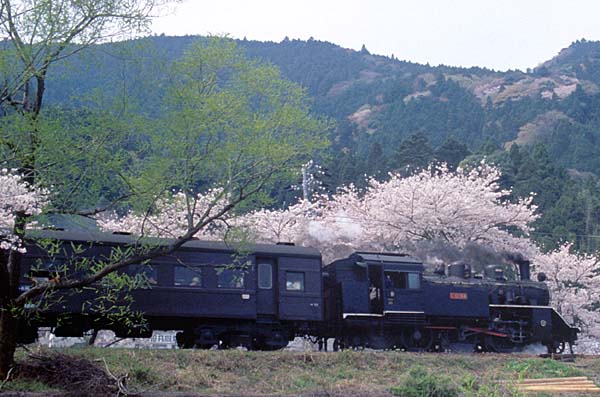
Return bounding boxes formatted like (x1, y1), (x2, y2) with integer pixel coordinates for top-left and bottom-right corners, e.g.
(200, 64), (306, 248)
(21, 231), (323, 349)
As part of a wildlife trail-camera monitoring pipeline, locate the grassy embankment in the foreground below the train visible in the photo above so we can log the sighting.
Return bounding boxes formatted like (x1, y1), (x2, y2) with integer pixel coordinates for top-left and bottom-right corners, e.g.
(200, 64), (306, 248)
(3, 348), (600, 397)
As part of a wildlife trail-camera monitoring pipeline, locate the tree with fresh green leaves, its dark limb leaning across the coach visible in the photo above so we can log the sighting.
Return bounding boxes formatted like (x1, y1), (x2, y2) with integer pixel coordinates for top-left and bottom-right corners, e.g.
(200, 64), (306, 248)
(0, 1), (329, 377)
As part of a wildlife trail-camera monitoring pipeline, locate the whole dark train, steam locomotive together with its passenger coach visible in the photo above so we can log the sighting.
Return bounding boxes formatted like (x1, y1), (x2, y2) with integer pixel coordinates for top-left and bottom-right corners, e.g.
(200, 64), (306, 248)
(14, 231), (578, 352)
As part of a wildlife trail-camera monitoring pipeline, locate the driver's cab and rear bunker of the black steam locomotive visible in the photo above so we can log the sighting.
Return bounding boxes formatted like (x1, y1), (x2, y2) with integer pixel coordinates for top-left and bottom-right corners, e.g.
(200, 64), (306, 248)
(325, 252), (425, 348)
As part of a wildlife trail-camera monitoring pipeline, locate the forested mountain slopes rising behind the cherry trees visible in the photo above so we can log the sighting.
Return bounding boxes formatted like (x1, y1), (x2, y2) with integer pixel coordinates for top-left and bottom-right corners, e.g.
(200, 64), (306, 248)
(43, 36), (600, 250)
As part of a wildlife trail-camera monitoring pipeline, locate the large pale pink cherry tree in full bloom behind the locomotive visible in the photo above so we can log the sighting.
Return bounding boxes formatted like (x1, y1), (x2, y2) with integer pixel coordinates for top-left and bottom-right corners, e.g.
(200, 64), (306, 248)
(312, 163), (538, 258)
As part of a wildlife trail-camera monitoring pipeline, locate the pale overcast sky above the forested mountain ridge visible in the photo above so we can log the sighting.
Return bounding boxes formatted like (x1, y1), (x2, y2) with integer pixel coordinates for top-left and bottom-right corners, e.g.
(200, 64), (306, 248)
(152, 0), (600, 70)
